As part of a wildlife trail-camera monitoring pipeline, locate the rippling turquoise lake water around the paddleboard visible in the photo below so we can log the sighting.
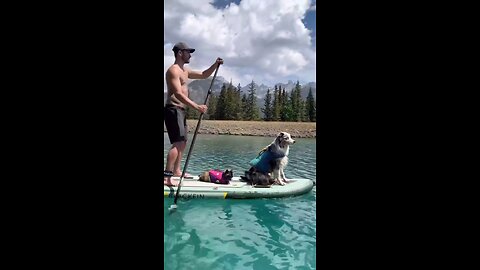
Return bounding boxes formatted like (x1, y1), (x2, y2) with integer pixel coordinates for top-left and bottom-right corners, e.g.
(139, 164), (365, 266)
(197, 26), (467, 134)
(163, 133), (318, 270)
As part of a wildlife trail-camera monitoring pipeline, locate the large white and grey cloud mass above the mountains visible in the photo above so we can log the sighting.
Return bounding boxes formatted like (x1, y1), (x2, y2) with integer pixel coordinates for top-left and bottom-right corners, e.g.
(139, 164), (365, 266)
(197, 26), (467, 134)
(164, 0), (316, 90)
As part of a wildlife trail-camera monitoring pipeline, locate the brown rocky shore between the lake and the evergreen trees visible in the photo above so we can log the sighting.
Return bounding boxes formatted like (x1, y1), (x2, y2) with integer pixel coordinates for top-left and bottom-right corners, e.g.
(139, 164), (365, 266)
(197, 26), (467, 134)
(164, 120), (317, 138)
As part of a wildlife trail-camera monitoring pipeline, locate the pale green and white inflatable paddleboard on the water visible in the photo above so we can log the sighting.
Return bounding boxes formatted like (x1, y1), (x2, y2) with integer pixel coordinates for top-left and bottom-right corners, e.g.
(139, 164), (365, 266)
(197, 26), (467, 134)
(163, 176), (314, 199)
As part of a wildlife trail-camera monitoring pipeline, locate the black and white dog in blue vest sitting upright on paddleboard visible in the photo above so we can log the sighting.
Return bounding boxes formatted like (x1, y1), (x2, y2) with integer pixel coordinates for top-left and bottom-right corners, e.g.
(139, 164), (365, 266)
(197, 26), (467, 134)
(242, 132), (295, 186)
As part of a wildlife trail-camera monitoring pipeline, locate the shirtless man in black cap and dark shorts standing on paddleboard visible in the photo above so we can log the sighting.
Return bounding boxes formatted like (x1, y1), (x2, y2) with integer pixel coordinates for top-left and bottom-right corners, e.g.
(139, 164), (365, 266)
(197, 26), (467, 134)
(163, 42), (223, 186)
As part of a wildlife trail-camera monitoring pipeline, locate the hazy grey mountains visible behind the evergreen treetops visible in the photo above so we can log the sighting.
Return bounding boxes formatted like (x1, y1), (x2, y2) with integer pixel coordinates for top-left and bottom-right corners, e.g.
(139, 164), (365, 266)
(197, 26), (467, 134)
(163, 76), (317, 107)
